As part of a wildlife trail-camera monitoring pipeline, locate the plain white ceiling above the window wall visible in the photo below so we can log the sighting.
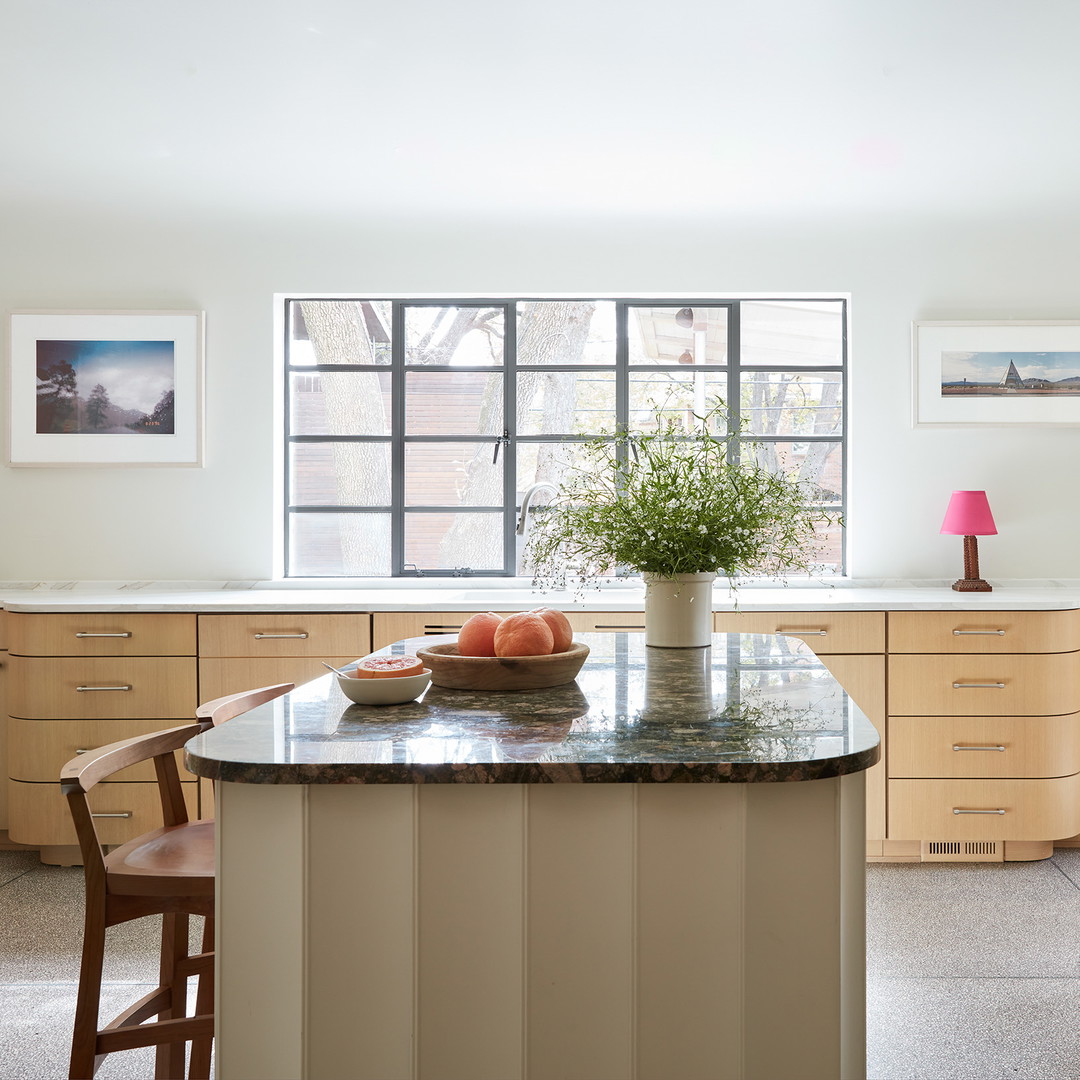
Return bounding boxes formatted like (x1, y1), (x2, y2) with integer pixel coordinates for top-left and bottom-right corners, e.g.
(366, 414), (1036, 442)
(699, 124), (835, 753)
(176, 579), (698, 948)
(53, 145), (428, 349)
(0, 0), (1080, 219)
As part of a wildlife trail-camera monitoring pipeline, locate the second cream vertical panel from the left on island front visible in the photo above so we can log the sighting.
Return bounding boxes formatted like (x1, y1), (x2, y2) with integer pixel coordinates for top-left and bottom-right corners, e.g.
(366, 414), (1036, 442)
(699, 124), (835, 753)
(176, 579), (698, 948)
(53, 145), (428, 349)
(311, 784), (417, 1080)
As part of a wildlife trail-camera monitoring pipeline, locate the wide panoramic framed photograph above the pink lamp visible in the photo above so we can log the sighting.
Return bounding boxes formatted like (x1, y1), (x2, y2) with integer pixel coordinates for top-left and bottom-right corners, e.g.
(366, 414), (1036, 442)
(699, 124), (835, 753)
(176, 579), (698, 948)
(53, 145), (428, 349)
(912, 322), (1080, 428)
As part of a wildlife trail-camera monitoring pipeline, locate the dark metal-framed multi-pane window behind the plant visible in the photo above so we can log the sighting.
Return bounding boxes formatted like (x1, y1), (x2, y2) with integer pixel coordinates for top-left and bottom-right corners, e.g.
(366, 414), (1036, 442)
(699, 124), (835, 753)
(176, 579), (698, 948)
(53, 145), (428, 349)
(284, 297), (847, 577)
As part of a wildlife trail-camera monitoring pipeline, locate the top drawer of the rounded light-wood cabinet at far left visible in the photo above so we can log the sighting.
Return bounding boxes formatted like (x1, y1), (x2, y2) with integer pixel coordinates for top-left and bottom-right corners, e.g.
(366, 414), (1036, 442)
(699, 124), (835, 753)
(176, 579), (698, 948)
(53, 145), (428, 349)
(8, 611), (195, 657)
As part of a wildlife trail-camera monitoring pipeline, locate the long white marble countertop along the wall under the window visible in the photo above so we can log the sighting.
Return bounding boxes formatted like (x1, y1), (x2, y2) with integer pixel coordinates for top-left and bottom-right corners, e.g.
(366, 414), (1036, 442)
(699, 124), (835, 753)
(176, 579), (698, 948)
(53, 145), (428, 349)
(0, 579), (1080, 612)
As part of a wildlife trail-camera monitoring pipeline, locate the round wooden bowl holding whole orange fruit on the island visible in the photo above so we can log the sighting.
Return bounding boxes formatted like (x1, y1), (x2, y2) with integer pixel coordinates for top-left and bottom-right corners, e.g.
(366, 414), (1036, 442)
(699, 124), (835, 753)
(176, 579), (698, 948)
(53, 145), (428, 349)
(416, 608), (589, 690)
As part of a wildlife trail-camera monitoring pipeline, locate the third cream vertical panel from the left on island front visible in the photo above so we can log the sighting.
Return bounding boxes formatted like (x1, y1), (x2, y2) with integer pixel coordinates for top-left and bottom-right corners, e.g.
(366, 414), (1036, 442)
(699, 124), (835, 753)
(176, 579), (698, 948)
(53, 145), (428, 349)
(417, 784), (524, 1080)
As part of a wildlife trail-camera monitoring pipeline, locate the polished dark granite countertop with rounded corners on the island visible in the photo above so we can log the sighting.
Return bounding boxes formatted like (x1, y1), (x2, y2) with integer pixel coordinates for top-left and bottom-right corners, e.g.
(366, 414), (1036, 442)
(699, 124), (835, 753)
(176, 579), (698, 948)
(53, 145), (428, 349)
(186, 633), (879, 784)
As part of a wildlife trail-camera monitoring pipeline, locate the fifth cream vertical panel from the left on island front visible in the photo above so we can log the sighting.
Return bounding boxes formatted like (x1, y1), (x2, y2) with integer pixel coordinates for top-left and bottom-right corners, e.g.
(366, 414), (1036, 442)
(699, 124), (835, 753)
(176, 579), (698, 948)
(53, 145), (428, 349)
(637, 784), (746, 1080)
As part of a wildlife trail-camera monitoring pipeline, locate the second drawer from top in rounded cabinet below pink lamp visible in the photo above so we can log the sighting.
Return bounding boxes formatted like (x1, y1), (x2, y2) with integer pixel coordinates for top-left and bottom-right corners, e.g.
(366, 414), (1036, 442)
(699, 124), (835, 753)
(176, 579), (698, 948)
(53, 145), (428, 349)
(889, 652), (1080, 716)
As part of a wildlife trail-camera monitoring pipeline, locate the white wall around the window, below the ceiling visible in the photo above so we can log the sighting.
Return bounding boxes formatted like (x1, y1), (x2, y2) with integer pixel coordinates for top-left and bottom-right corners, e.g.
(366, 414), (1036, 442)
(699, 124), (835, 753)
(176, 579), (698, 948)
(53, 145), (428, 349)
(0, 208), (1080, 580)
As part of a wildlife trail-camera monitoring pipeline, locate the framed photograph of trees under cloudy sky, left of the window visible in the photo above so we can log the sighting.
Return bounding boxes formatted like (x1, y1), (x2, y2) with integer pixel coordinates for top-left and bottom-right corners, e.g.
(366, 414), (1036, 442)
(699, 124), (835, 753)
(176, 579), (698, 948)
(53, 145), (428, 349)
(8, 311), (203, 465)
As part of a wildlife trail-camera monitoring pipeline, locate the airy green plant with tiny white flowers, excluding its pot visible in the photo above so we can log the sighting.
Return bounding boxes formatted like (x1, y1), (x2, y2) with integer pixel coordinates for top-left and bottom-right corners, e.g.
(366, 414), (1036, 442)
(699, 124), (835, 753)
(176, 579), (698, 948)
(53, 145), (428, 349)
(527, 403), (838, 585)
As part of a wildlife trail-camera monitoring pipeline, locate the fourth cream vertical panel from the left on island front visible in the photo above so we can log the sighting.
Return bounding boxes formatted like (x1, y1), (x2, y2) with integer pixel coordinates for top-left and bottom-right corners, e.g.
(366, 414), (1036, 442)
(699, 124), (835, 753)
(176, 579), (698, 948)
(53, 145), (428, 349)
(526, 784), (636, 1080)
